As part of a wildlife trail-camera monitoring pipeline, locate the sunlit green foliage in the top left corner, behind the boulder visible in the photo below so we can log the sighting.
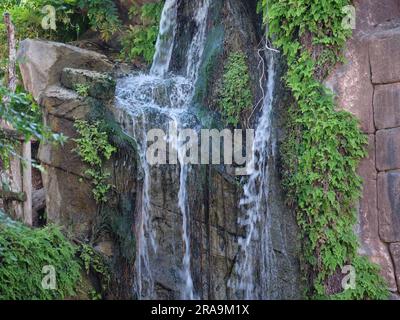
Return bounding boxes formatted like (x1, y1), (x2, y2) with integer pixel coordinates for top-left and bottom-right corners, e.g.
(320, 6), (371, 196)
(0, 0), (121, 73)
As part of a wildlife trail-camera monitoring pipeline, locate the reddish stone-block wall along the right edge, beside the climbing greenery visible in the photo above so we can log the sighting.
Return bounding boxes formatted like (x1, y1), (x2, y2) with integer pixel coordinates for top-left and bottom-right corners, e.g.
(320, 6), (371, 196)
(327, 0), (400, 297)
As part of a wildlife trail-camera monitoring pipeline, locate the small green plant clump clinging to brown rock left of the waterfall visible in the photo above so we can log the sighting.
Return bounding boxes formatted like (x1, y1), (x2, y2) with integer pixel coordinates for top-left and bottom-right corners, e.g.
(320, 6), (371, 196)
(74, 120), (116, 202)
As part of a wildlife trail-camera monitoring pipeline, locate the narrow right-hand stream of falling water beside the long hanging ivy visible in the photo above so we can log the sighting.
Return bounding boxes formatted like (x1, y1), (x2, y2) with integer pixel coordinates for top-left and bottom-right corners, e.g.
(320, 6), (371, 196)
(235, 47), (277, 299)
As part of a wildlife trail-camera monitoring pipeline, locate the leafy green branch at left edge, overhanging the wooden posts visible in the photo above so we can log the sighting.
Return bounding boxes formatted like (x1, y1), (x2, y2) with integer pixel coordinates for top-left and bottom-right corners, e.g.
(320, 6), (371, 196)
(0, 86), (66, 167)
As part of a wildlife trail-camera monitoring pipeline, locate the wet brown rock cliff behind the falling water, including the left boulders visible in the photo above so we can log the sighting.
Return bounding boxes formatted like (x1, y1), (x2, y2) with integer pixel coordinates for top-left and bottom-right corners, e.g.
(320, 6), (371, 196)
(19, 0), (301, 299)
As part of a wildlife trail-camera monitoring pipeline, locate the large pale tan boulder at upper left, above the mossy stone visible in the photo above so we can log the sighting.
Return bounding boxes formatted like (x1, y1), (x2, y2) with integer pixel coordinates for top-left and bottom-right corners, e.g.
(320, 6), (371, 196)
(17, 39), (113, 103)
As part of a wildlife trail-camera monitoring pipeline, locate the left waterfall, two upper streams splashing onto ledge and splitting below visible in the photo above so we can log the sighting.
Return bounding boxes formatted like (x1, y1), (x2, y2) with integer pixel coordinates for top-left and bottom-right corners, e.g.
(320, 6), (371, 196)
(116, 0), (210, 299)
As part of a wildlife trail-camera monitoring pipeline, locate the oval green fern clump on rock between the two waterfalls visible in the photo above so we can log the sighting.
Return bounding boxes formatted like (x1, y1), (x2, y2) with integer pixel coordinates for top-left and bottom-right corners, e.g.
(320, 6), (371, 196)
(219, 52), (253, 126)
